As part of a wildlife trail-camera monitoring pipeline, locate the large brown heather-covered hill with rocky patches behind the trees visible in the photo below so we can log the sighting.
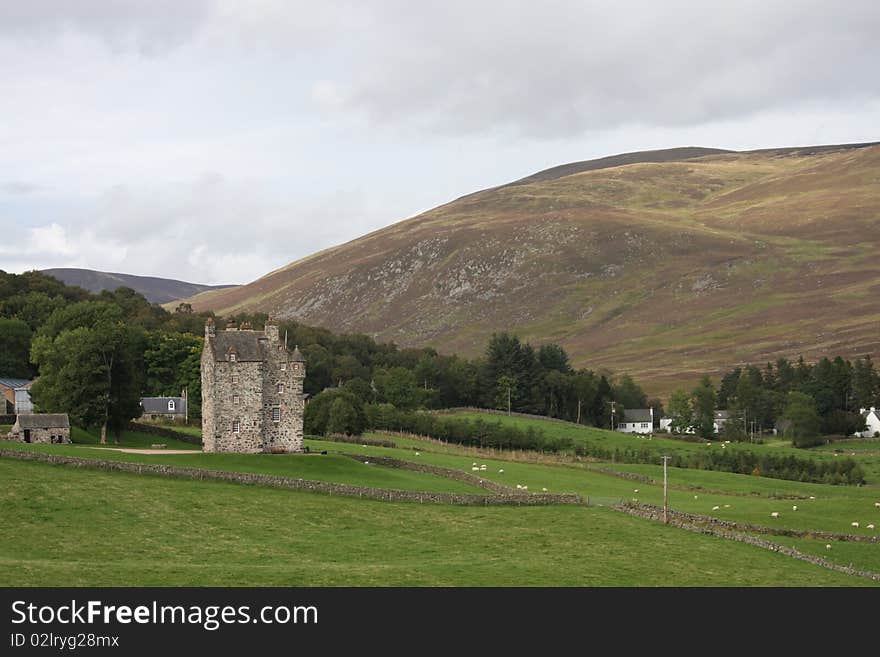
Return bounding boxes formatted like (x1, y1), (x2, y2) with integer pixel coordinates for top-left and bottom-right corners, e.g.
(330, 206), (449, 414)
(191, 145), (880, 393)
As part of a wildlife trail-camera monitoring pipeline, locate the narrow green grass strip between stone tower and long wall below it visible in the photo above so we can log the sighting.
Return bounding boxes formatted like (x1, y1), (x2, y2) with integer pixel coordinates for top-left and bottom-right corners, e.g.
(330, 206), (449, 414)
(0, 442), (486, 495)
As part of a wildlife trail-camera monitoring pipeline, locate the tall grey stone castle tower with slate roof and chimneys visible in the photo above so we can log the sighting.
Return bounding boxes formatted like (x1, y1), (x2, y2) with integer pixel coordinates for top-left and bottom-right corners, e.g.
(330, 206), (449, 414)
(202, 318), (306, 453)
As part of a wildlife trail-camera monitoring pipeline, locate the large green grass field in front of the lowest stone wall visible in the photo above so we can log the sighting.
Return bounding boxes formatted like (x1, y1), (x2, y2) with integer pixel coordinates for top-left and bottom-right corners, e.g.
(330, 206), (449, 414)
(0, 460), (871, 586)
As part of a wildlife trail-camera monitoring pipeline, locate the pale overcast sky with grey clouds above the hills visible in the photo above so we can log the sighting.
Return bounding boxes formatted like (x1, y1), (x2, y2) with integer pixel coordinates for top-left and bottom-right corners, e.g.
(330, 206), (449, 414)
(0, 0), (880, 283)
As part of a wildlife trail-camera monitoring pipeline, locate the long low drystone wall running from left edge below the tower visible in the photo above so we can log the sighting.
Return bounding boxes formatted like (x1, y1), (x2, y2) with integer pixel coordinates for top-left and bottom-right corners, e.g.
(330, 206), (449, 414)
(0, 448), (583, 506)
